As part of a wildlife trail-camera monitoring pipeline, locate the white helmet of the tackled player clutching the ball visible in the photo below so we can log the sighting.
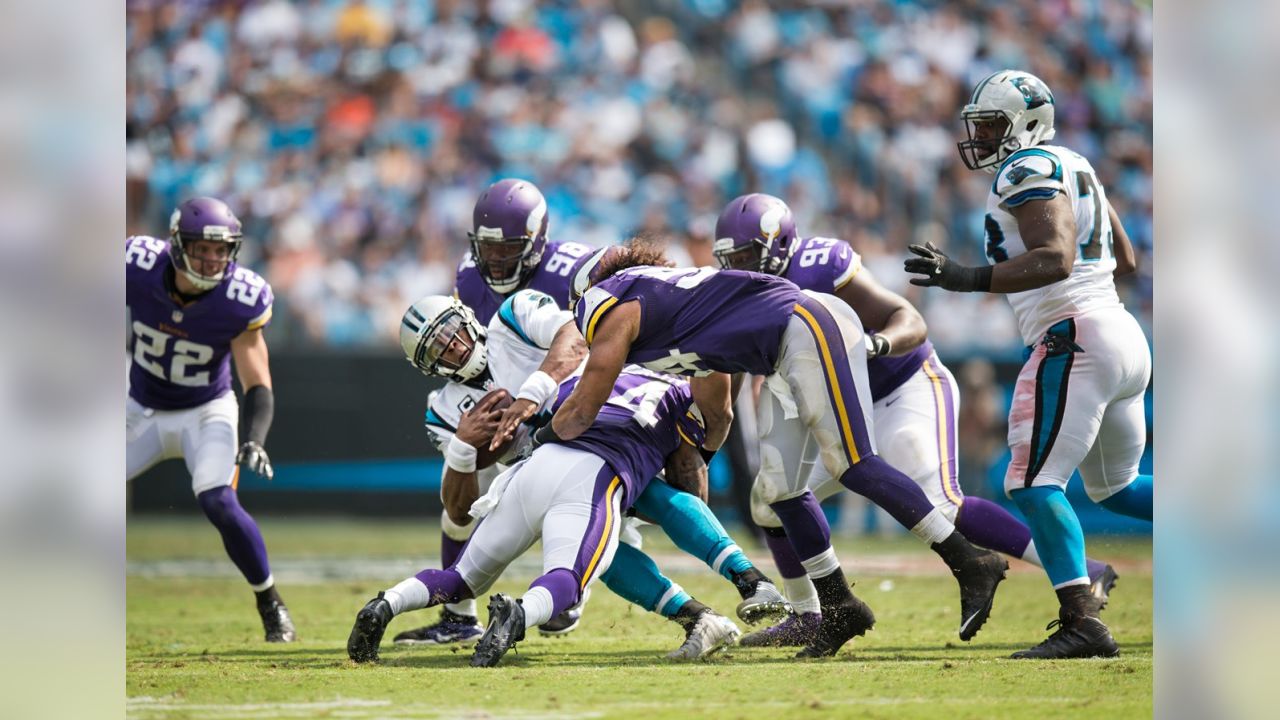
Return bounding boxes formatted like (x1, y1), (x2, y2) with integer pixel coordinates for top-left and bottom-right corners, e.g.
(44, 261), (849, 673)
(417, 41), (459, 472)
(401, 295), (489, 383)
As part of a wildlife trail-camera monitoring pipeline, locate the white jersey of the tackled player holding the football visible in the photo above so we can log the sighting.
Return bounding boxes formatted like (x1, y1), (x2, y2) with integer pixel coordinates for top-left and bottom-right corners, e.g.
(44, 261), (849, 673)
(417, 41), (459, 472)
(426, 290), (573, 450)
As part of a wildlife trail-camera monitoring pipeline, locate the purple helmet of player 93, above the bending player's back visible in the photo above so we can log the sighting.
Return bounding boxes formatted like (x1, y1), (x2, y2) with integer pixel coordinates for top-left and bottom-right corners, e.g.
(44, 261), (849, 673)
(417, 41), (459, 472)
(712, 192), (799, 275)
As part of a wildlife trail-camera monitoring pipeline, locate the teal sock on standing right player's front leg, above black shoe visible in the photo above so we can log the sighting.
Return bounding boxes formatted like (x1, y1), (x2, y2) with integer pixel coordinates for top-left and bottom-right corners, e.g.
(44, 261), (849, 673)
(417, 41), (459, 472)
(1009, 487), (1089, 588)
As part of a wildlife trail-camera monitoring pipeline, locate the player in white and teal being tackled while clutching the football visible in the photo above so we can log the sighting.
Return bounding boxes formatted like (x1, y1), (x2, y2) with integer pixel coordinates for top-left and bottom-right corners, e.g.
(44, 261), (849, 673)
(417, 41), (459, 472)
(381, 290), (786, 653)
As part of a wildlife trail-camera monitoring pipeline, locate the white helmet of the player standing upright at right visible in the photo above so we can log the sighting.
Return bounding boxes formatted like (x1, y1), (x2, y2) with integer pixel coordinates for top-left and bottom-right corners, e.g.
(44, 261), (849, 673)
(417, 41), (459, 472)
(956, 70), (1053, 173)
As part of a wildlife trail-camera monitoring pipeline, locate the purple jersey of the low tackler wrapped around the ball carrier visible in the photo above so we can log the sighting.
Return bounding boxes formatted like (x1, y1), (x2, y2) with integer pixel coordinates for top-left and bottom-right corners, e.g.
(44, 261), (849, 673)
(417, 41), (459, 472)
(553, 365), (705, 510)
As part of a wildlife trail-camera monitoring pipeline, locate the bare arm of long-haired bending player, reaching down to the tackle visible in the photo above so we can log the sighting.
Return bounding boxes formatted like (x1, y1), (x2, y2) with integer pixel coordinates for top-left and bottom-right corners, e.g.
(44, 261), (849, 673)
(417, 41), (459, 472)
(536, 301), (640, 441)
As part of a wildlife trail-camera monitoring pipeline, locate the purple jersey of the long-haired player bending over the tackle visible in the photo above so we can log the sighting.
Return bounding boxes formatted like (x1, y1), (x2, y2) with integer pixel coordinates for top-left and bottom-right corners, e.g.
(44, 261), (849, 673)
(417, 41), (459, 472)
(575, 268), (804, 375)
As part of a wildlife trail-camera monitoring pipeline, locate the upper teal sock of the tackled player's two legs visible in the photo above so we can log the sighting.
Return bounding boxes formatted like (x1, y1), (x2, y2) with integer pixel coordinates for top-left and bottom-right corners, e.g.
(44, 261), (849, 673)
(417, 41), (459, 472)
(635, 480), (751, 580)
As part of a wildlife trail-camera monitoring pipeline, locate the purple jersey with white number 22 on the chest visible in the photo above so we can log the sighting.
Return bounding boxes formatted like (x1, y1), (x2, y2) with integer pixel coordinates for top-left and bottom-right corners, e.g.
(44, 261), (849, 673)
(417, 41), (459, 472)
(124, 236), (273, 410)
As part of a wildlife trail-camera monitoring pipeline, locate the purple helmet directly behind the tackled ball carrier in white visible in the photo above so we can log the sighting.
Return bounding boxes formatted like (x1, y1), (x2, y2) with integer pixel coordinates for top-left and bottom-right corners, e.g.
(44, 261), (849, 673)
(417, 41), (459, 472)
(467, 178), (547, 295)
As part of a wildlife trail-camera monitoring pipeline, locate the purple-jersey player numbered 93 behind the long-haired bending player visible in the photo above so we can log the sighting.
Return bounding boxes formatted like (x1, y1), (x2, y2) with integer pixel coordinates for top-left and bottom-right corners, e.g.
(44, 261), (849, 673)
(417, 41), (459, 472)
(713, 193), (1116, 646)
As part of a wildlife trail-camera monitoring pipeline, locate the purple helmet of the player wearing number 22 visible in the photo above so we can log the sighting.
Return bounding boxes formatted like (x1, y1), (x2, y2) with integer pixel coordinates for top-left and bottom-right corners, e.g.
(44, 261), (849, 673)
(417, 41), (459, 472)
(169, 197), (242, 290)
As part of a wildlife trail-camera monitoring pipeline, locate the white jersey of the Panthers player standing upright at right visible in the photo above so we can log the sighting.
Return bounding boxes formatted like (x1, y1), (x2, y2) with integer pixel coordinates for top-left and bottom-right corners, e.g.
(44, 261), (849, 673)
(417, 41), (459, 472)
(984, 145), (1123, 346)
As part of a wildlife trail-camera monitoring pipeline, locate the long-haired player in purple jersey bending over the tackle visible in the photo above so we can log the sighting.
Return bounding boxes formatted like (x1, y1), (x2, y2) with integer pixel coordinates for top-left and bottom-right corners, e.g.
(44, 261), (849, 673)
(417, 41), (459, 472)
(550, 242), (1007, 657)
